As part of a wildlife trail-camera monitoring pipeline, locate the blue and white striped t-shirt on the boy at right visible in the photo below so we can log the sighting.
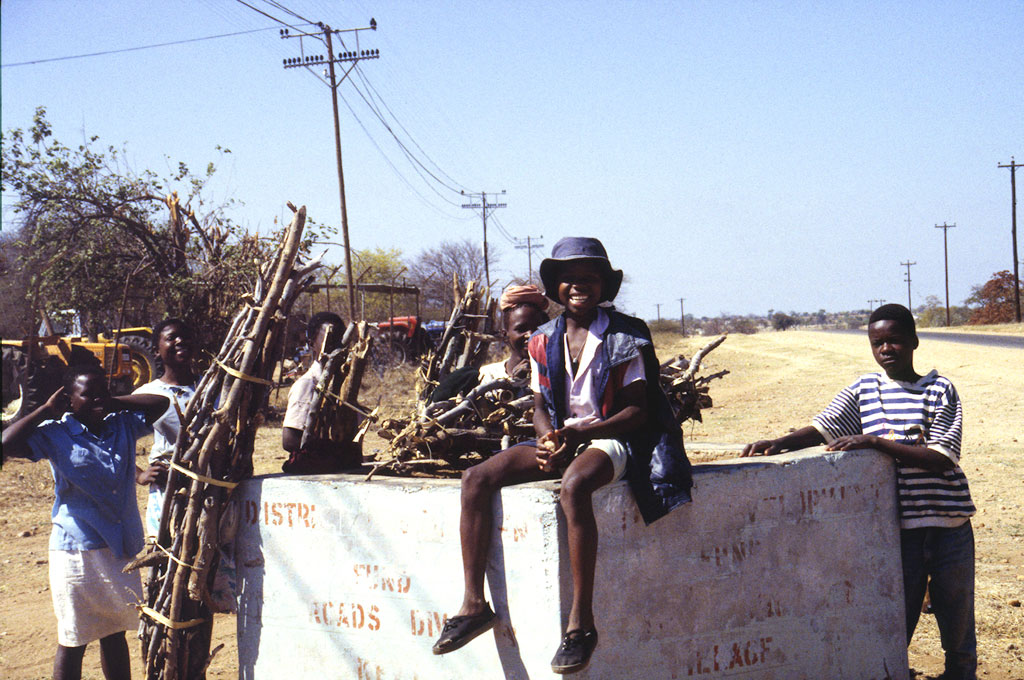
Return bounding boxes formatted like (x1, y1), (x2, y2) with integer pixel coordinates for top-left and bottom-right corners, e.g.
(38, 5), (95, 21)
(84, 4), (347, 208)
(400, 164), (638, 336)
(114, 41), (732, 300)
(812, 371), (975, 528)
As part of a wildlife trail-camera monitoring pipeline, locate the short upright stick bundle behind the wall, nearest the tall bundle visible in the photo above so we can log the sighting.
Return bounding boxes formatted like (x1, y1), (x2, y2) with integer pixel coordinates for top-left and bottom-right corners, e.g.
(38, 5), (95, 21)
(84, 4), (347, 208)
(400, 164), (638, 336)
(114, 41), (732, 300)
(299, 322), (374, 450)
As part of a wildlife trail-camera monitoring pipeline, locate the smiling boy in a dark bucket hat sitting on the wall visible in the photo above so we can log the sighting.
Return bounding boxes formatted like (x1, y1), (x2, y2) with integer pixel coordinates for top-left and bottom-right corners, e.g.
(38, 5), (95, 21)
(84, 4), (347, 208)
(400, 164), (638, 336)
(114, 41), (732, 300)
(433, 237), (692, 674)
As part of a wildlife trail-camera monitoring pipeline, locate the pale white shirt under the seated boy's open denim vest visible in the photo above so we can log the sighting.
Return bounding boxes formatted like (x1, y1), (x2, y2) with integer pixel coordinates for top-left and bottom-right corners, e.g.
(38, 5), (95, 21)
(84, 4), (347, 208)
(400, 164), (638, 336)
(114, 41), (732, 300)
(529, 307), (646, 425)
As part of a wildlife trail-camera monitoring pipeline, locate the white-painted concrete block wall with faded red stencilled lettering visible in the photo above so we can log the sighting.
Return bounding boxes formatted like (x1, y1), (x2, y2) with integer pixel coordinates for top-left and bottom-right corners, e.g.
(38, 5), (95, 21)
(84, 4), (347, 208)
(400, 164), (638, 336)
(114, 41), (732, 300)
(237, 452), (907, 680)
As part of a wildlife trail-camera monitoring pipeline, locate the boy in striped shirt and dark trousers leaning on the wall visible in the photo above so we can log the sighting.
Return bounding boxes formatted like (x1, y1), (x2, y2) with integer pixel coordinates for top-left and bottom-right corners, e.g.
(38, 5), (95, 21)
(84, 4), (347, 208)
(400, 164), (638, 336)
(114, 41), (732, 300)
(742, 304), (978, 680)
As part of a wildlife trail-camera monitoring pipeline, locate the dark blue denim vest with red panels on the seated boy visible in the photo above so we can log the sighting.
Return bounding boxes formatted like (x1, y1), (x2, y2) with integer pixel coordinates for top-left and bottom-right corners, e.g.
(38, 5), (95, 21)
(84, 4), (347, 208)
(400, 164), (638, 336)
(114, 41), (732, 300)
(529, 310), (693, 524)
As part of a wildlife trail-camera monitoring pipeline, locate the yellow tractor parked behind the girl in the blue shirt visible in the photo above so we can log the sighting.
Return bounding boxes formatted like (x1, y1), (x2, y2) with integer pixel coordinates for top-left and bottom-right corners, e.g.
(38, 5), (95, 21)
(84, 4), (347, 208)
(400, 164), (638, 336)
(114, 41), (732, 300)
(2, 327), (159, 424)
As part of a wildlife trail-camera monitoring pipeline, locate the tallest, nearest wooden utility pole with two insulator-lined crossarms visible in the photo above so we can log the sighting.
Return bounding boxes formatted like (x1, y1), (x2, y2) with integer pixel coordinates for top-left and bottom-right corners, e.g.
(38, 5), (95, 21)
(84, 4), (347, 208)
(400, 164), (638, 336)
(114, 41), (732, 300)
(281, 18), (380, 321)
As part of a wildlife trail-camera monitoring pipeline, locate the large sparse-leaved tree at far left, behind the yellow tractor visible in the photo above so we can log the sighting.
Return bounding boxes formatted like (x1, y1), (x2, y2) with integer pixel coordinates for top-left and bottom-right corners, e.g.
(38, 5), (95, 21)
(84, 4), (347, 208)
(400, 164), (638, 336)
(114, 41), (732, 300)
(0, 108), (270, 345)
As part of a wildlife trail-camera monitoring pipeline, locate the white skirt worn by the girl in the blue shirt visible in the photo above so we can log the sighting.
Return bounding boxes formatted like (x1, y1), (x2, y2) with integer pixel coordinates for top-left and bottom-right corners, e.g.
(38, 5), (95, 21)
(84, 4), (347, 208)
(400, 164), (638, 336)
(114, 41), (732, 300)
(49, 548), (142, 647)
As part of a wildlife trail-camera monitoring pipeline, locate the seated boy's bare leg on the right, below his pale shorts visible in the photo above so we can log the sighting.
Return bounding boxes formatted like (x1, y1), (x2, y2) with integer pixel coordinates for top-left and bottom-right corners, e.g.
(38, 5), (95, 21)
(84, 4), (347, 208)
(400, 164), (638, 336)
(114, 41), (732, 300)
(560, 449), (614, 632)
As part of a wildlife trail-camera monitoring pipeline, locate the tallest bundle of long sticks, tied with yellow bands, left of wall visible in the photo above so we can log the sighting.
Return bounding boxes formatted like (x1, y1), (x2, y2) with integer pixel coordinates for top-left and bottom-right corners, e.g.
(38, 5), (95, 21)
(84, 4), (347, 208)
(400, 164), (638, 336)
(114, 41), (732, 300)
(125, 204), (319, 680)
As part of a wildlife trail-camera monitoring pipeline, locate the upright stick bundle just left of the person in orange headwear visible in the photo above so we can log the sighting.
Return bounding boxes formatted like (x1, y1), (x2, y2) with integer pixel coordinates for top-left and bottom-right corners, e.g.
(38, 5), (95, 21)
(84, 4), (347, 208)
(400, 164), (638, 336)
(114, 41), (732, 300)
(416, 274), (498, 403)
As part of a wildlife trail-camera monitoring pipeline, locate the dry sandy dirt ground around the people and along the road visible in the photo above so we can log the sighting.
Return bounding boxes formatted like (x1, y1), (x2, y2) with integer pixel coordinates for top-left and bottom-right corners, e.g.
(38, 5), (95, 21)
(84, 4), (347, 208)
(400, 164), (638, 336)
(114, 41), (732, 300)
(0, 327), (1024, 680)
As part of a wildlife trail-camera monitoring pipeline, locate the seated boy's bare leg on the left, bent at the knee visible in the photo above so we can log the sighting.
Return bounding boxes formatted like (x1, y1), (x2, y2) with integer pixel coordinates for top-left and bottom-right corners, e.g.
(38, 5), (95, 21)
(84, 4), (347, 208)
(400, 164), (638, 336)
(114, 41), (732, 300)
(457, 445), (552, 617)
